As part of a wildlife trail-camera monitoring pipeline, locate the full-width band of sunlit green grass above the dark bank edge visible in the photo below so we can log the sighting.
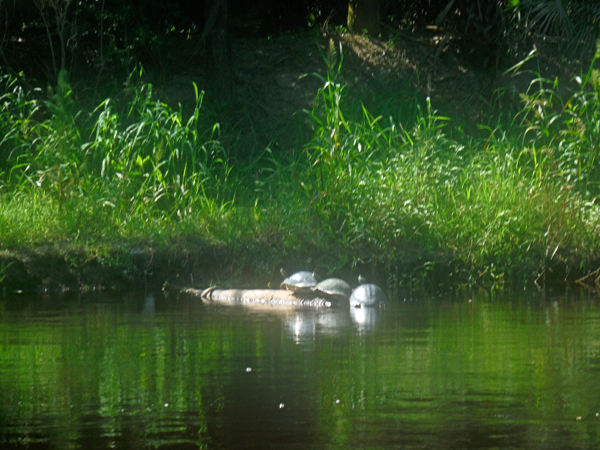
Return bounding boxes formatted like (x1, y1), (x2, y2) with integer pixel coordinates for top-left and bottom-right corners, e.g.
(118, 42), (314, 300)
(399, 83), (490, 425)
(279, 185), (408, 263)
(0, 42), (600, 283)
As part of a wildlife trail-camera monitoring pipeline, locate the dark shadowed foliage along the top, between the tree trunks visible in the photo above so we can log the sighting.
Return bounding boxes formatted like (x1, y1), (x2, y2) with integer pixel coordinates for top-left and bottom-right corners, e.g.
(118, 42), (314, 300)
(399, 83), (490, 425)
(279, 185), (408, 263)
(0, 0), (600, 89)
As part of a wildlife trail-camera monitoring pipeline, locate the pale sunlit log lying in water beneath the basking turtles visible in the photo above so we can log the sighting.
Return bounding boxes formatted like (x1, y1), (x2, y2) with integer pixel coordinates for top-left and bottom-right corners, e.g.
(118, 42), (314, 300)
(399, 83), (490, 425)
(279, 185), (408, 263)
(181, 288), (333, 308)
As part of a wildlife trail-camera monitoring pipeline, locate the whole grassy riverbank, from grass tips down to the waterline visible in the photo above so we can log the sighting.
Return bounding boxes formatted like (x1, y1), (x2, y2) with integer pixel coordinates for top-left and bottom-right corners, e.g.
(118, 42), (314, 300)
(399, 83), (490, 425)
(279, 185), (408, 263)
(0, 31), (600, 293)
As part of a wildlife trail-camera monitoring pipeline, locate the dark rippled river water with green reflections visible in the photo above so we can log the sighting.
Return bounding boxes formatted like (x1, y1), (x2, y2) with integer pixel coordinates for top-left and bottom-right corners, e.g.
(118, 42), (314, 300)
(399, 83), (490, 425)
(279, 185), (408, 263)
(0, 292), (600, 450)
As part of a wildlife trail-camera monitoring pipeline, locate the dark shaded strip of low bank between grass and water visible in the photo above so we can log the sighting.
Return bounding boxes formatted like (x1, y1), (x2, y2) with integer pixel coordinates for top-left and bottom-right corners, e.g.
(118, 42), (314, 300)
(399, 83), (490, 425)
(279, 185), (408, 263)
(0, 234), (600, 296)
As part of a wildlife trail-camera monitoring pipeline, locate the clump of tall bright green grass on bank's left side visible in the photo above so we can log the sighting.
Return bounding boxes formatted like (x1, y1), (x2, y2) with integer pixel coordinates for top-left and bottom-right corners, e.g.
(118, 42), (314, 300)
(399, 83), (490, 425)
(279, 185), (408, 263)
(0, 67), (239, 243)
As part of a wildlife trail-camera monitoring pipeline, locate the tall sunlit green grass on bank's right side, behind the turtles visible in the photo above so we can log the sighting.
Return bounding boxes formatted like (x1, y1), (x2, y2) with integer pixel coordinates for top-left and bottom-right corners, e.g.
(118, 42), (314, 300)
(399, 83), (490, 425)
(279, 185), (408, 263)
(292, 41), (600, 279)
